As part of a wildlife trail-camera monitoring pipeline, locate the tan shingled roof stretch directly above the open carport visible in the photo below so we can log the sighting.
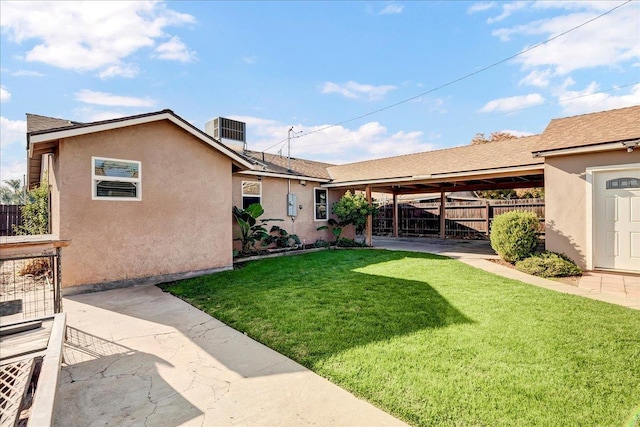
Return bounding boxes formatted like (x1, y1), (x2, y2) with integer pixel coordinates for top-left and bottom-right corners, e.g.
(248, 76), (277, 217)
(328, 135), (544, 183)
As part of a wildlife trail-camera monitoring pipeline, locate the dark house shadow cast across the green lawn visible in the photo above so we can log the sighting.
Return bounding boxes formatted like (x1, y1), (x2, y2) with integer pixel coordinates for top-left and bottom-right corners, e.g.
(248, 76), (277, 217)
(162, 250), (472, 367)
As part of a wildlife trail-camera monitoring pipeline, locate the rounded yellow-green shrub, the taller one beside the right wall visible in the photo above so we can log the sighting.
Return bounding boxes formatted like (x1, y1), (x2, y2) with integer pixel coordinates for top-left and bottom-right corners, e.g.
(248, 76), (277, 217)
(491, 211), (540, 263)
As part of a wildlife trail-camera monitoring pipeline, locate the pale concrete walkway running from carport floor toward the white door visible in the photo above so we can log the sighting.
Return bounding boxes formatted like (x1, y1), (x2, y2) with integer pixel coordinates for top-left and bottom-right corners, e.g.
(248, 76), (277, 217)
(373, 237), (640, 310)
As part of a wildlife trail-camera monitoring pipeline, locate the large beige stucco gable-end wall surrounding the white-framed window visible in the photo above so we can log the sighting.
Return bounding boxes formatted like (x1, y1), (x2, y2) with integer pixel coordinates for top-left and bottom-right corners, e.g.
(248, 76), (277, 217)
(54, 121), (232, 287)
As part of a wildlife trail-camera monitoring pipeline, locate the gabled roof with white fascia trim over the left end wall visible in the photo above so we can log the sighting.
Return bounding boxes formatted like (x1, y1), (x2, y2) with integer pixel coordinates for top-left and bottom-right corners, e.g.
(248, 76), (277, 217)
(27, 110), (254, 185)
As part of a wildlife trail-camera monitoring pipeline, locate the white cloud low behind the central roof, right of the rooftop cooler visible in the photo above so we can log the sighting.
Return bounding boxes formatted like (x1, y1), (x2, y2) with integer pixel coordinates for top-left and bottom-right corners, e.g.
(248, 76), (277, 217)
(233, 116), (439, 164)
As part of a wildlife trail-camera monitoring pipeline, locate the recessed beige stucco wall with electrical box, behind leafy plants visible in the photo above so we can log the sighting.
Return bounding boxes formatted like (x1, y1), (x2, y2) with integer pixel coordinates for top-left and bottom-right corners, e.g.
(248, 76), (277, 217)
(233, 174), (353, 249)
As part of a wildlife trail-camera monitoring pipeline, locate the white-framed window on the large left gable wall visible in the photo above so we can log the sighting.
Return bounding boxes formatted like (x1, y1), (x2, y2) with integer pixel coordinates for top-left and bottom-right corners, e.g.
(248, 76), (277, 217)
(91, 157), (142, 200)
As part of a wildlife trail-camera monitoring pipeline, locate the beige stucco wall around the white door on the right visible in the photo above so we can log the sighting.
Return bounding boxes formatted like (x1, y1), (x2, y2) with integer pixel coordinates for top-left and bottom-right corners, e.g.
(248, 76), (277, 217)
(544, 148), (638, 268)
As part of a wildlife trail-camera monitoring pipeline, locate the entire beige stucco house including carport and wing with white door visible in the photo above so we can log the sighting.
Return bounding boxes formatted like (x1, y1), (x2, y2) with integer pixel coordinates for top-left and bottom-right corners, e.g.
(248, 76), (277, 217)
(22, 106), (640, 293)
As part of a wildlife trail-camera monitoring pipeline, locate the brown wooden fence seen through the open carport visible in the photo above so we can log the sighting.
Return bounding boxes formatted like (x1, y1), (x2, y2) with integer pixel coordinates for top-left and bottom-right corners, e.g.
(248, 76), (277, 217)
(373, 199), (544, 238)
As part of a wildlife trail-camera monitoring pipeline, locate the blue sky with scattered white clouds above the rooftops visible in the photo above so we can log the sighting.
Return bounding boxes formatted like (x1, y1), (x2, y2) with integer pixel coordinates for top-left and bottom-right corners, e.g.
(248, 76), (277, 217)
(0, 1), (640, 180)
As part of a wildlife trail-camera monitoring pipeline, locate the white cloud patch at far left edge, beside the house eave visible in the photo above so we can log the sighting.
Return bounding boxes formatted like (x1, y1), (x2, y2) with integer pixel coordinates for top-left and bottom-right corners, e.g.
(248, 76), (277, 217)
(0, 116), (27, 181)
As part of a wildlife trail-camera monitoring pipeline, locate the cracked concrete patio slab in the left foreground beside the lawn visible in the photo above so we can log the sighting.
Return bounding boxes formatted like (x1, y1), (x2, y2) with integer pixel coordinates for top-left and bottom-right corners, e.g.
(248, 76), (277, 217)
(55, 286), (406, 426)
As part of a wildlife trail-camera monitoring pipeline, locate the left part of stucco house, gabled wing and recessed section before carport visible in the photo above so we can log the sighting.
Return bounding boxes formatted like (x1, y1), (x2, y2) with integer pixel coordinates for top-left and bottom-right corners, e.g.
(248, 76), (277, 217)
(27, 110), (340, 293)
